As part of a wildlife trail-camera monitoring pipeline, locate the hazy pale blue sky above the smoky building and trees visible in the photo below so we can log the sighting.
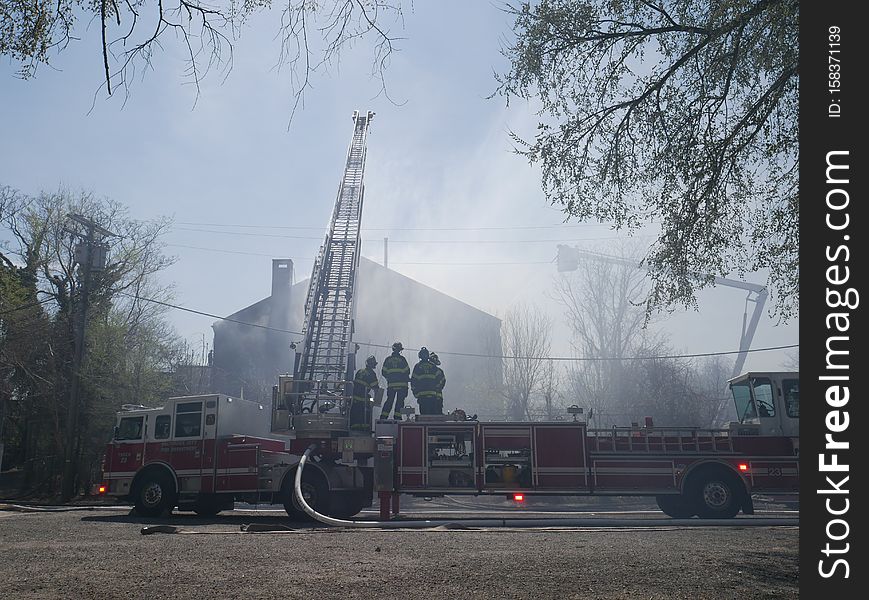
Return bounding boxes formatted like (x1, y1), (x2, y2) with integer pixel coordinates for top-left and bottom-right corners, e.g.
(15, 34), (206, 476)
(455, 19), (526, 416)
(0, 0), (798, 370)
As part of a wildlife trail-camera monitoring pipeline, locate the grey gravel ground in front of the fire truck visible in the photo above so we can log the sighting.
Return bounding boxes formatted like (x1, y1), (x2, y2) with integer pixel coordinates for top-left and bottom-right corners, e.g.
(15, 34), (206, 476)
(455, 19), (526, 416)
(0, 508), (799, 600)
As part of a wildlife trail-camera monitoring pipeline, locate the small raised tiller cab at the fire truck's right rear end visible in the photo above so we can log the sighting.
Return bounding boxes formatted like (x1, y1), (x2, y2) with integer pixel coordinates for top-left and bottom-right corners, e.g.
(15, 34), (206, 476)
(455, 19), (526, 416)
(728, 371), (800, 438)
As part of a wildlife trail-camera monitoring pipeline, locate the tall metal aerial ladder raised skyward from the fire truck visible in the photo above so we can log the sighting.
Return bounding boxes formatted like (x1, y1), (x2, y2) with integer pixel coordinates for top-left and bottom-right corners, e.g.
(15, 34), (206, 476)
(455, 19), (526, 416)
(293, 111), (374, 430)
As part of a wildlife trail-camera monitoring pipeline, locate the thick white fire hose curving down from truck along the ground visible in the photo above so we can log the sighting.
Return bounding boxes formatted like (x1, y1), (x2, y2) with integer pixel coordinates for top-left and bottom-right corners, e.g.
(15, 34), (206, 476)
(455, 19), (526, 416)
(294, 444), (782, 529)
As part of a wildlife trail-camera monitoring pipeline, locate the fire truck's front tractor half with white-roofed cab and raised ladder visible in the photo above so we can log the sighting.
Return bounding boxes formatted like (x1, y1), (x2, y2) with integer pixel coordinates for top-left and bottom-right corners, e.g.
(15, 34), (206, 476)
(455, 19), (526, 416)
(100, 111), (374, 517)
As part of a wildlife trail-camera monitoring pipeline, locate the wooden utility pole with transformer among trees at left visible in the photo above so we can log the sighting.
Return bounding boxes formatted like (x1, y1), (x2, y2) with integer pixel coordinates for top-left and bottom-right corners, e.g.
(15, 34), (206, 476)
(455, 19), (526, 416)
(61, 214), (115, 502)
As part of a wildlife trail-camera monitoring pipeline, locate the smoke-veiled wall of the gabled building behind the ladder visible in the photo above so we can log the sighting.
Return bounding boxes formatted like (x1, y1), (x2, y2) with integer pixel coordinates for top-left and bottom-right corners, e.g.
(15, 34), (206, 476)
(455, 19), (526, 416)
(208, 258), (501, 413)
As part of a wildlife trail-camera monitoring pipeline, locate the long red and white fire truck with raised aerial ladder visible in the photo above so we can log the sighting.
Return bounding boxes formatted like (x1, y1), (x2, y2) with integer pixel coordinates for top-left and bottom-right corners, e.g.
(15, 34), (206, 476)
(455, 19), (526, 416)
(102, 111), (799, 519)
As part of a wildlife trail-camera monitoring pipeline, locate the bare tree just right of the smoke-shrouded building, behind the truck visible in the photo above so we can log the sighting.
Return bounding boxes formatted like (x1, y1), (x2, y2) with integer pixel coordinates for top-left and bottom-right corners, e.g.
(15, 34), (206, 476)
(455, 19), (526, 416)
(501, 305), (552, 421)
